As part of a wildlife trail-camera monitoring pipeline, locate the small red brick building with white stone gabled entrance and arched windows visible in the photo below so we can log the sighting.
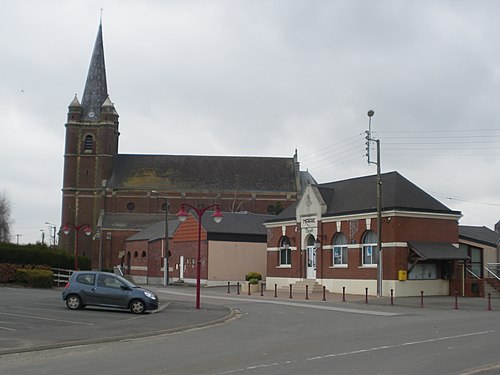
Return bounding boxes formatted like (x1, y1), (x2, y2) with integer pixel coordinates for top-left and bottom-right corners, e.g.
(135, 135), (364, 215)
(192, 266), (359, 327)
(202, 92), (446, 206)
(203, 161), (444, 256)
(264, 172), (468, 296)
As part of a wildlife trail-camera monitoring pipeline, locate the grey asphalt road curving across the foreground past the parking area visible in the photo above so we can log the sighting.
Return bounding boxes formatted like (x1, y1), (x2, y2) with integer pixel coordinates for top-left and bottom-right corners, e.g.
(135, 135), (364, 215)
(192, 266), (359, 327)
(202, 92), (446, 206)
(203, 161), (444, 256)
(0, 288), (500, 375)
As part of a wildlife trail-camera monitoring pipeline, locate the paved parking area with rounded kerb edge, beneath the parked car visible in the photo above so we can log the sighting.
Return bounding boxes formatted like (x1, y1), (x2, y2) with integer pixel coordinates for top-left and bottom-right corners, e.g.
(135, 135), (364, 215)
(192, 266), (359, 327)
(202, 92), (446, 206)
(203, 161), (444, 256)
(0, 287), (232, 355)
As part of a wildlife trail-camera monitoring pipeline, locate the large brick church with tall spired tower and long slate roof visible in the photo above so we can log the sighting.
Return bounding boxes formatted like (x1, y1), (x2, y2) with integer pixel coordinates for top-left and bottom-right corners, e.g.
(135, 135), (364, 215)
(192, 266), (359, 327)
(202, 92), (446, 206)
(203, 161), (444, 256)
(60, 23), (315, 269)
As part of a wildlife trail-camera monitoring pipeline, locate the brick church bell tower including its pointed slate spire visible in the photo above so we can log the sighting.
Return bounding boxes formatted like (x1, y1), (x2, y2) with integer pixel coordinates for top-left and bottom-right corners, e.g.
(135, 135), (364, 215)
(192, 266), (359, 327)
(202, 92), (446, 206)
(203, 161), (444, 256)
(59, 22), (120, 269)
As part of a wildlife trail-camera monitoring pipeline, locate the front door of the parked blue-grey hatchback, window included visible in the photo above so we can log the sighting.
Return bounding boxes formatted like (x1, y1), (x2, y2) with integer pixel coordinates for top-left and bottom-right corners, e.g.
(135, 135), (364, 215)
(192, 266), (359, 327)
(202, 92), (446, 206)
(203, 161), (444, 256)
(94, 274), (130, 308)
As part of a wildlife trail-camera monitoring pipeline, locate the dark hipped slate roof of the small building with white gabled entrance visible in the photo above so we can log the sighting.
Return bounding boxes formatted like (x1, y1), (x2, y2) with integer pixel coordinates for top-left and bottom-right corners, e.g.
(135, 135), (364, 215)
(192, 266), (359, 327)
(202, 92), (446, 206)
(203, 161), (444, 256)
(318, 172), (460, 216)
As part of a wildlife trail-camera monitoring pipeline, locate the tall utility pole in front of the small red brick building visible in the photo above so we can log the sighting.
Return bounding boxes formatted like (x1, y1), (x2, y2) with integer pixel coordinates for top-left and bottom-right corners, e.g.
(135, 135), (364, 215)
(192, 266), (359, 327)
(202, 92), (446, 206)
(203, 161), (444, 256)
(366, 109), (383, 297)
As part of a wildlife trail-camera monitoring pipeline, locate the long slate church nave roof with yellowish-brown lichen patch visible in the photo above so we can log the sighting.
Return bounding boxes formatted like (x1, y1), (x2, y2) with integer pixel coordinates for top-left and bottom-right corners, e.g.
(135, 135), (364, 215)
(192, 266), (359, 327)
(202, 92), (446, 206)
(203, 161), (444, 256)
(108, 154), (297, 193)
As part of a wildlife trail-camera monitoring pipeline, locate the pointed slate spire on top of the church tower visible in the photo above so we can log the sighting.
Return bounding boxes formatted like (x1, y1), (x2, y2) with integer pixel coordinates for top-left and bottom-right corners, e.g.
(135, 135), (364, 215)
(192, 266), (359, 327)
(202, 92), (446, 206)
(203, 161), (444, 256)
(82, 22), (108, 122)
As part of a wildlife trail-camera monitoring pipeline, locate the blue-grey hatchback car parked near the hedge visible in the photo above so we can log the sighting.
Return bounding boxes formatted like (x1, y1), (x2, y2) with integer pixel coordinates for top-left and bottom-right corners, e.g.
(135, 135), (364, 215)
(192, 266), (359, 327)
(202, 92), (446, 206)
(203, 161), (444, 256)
(62, 271), (159, 314)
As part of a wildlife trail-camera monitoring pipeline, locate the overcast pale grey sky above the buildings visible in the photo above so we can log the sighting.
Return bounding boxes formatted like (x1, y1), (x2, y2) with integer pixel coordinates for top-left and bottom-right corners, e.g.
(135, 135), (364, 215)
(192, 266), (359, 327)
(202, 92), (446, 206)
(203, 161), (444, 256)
(0, 0), (500, 243)
